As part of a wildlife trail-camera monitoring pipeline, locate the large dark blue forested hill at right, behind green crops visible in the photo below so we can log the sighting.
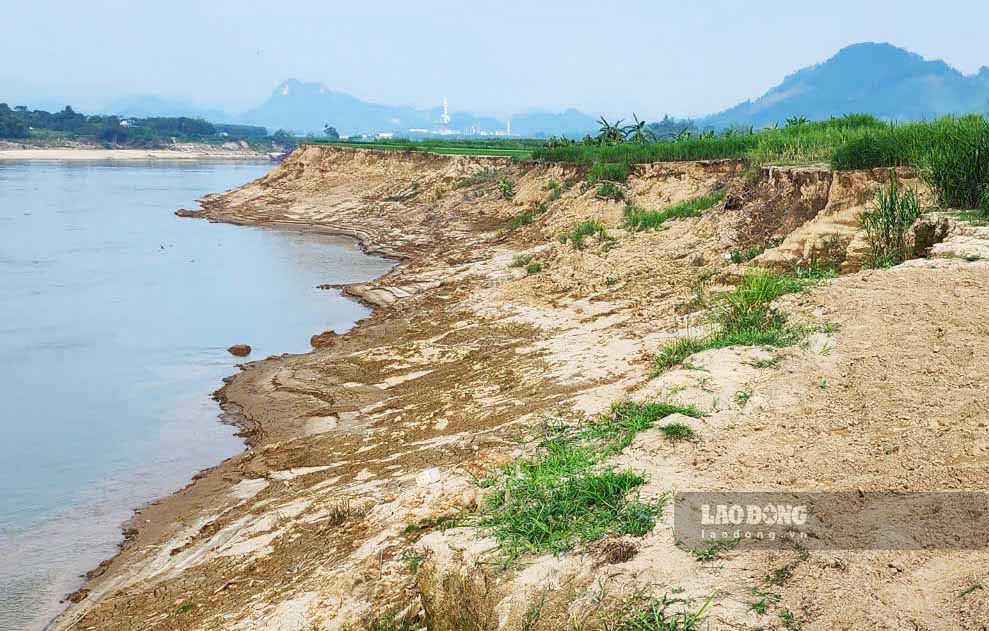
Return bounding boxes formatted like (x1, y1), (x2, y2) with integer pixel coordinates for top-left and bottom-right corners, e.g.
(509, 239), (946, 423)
(698, 43), (989, 128)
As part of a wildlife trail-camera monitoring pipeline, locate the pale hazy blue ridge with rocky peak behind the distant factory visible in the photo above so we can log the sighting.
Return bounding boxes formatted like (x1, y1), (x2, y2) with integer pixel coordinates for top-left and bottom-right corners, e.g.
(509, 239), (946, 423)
(238, 79), (597, 136)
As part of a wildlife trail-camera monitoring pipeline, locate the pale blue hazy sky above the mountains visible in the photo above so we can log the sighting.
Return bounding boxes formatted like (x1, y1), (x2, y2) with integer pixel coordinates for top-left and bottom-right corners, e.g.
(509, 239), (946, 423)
(0, 0), (989, 117)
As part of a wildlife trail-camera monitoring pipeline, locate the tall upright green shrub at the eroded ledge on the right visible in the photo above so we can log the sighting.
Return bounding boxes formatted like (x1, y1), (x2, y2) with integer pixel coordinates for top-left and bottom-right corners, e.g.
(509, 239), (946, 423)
(859, 173), (923, 267)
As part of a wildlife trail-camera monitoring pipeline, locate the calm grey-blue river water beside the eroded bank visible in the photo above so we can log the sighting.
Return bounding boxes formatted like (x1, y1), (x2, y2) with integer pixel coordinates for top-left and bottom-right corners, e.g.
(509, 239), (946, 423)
(0, 162), (391, 631)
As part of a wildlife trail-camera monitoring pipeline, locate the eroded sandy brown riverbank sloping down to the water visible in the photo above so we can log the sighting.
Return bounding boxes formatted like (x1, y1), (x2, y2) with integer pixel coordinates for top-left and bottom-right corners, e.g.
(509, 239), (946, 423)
(53, 147), (989, 631)
